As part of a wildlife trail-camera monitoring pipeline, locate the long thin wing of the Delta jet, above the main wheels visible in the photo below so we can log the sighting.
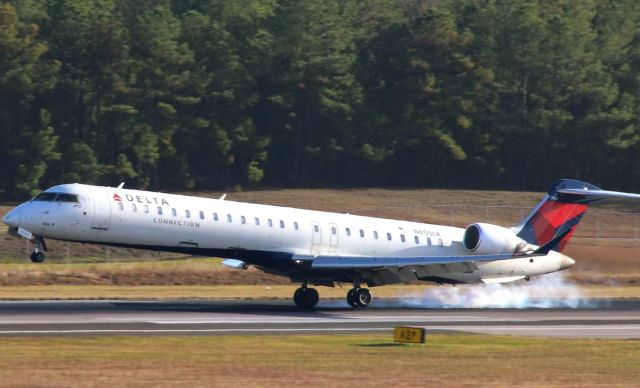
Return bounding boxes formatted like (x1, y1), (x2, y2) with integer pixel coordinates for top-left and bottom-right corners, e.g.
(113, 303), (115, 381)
(300, 253), (544, 270)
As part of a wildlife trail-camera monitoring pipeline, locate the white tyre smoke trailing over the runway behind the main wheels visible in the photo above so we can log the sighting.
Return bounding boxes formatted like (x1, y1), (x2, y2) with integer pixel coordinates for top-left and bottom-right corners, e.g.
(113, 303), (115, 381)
(390, 272), (598, 308)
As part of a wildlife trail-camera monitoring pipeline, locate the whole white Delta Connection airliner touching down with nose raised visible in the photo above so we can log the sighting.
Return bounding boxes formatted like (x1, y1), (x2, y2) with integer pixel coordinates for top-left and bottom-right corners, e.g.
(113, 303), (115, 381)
(2, 179), (640, 308)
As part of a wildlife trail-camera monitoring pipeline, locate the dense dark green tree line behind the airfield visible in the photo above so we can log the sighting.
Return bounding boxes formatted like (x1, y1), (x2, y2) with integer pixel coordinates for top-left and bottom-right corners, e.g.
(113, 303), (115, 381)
(0, 0), (640, 199)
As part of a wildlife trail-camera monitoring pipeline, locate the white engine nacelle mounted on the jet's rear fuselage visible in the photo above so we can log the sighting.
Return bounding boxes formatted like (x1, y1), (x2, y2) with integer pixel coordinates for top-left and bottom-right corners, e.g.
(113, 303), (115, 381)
(462, 223), (535, 255)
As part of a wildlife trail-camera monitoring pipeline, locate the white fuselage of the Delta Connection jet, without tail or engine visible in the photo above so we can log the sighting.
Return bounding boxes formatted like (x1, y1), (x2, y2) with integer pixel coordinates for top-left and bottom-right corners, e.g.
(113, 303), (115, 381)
(3, 184), (567, 284)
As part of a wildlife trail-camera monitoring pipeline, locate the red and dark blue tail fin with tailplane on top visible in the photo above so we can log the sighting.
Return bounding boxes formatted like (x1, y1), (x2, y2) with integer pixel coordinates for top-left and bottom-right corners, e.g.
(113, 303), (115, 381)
(515, 179), (640, 252)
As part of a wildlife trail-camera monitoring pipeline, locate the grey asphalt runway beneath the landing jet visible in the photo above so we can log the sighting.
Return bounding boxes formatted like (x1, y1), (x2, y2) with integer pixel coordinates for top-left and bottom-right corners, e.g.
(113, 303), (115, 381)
(0, 300), (640, 338)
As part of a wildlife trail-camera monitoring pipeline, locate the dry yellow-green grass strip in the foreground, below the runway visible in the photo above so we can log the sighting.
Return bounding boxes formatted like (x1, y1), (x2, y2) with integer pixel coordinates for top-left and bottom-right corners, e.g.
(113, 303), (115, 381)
(0, 332), (640, 387)
